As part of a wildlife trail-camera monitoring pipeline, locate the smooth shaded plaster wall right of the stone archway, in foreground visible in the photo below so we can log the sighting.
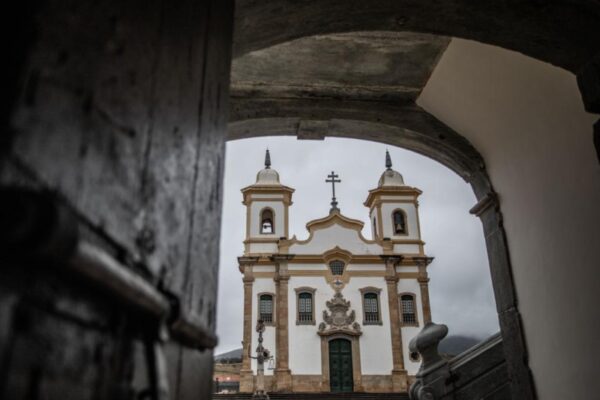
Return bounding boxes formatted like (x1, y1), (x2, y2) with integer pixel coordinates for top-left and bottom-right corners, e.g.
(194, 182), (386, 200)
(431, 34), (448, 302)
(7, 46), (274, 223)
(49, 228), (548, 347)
(418, 39), (600, 400)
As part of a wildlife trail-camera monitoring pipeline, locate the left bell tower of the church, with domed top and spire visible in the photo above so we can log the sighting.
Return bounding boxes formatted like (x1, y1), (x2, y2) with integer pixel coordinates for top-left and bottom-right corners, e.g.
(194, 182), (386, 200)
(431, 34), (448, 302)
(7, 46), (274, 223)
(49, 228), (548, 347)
(242, 149), (294, 255)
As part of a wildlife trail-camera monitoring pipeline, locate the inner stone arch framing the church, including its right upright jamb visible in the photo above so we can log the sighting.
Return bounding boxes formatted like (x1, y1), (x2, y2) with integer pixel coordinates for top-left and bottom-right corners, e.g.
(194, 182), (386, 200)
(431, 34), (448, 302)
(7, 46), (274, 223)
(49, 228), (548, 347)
(228, 117), (535, 399)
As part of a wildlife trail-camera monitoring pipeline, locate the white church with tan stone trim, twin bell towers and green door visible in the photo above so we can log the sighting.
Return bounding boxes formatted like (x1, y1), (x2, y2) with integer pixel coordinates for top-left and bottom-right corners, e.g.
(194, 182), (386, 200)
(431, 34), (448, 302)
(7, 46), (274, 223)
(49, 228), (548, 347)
(238, 150), (432, 393)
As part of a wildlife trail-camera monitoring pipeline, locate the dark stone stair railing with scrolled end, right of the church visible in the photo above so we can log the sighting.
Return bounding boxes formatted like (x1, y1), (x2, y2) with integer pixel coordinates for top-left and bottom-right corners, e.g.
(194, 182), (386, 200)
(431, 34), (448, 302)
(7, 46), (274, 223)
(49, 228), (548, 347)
(409, 323), (511, 400)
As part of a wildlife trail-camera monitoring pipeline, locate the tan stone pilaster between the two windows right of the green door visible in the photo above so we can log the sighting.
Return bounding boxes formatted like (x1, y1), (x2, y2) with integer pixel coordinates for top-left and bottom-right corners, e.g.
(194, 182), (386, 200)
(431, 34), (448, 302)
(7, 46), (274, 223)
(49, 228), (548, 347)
(383, 256), (408, 392)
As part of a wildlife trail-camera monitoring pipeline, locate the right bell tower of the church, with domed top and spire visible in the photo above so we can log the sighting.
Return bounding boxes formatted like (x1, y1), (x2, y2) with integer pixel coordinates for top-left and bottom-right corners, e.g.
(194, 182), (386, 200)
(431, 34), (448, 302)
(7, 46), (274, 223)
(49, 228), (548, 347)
(364, 150), (424, 254)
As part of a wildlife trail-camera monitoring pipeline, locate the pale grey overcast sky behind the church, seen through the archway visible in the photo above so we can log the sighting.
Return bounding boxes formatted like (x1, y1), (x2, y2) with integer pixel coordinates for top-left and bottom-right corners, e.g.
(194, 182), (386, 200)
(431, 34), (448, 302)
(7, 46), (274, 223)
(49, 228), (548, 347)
(215, 137), (498, 354)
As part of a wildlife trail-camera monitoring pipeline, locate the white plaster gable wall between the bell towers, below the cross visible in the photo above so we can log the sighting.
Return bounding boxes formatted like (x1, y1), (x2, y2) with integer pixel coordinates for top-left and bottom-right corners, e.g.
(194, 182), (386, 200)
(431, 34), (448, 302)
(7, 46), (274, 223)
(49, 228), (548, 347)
(289, 224), (383, 254)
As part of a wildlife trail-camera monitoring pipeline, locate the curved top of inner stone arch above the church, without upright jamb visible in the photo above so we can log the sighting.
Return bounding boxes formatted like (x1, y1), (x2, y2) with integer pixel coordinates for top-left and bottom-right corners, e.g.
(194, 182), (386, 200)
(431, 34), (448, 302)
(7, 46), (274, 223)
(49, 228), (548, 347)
(228, 115), (489, 182)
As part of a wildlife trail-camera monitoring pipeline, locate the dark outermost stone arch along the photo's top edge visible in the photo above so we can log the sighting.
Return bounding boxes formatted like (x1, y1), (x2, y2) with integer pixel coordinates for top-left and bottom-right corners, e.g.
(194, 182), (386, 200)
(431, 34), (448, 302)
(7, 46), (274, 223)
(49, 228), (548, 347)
(233, 0), (600, 73)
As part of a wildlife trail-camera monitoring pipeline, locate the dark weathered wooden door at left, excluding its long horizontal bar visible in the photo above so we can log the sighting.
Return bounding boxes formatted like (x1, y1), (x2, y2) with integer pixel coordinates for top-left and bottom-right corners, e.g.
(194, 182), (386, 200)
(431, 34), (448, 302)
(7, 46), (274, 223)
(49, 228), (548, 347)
(0, 0), (233, 399)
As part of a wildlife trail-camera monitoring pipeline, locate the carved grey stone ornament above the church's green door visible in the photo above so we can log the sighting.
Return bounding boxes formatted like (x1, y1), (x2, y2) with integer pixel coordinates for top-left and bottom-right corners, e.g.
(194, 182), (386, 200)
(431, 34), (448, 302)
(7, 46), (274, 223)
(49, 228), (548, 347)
(318, 291), (362, 336)
